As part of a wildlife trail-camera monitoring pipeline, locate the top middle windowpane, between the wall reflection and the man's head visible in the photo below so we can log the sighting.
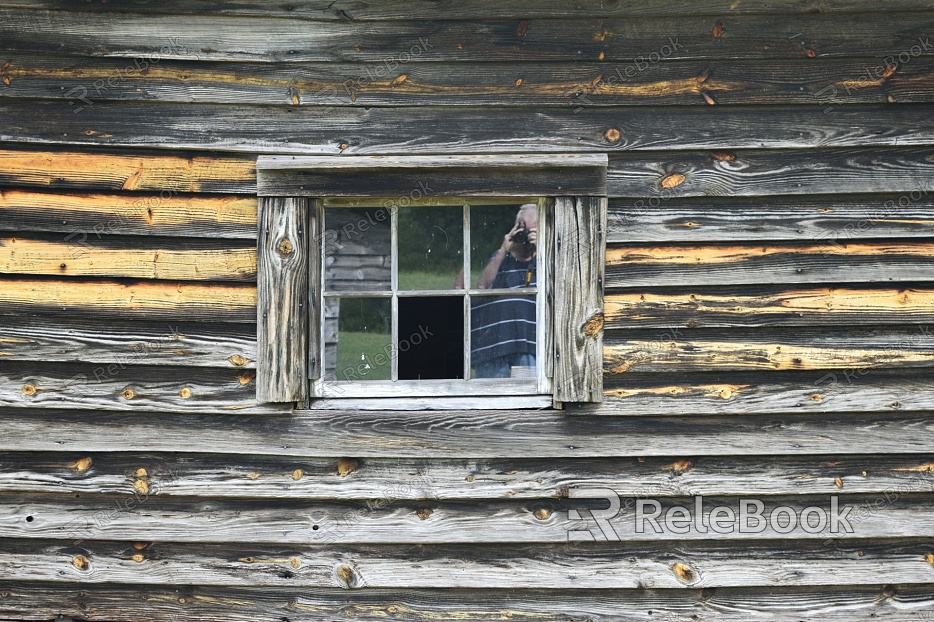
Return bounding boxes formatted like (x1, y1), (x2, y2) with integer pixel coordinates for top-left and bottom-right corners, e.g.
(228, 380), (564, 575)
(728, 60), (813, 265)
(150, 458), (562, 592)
(399, 205), (464, 292)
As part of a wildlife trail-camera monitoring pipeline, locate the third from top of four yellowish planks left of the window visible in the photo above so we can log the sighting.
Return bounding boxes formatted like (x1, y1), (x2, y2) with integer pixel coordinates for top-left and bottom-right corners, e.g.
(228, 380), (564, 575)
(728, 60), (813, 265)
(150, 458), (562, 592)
(0, 232), (256, 282)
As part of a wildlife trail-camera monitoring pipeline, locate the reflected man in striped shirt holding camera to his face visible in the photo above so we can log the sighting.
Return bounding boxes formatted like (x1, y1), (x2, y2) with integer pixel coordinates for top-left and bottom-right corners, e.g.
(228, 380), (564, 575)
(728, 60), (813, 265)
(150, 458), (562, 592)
(470, 203), (538, 378)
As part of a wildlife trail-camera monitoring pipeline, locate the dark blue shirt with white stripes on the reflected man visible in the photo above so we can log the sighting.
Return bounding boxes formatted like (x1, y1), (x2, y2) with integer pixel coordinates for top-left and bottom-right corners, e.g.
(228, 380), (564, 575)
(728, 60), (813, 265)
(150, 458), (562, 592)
(470, 254), (535, 364)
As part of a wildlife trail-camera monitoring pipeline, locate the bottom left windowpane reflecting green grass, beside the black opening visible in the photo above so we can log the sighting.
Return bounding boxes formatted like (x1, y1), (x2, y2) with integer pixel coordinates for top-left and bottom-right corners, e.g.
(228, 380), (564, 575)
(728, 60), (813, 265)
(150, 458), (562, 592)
(324, 298), (392, 381)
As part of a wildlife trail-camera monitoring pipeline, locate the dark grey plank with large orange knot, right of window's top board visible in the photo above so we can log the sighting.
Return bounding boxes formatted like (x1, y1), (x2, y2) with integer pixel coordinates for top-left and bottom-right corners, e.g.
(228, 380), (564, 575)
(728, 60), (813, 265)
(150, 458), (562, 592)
(608, 147), (934, 196)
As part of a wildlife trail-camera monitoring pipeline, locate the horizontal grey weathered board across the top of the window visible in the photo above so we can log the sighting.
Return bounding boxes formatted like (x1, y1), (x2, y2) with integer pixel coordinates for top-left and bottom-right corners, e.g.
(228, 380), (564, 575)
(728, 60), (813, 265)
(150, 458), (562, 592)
(256, 154), (607, 196)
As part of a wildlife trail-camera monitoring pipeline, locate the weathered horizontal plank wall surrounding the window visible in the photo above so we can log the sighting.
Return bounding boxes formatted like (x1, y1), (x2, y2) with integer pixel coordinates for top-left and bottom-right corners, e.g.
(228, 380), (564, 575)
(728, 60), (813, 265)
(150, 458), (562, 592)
(0, 0), (934, 622)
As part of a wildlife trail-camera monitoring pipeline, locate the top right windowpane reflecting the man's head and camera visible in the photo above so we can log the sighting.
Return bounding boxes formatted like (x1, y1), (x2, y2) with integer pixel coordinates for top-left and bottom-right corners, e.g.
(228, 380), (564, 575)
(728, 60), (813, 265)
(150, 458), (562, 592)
(470, 203), (538, 289)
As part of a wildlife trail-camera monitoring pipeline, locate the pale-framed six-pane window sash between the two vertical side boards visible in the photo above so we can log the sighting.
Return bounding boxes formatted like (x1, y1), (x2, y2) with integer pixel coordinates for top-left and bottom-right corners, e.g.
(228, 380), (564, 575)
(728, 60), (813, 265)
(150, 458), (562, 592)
(320, 197), (550, 397)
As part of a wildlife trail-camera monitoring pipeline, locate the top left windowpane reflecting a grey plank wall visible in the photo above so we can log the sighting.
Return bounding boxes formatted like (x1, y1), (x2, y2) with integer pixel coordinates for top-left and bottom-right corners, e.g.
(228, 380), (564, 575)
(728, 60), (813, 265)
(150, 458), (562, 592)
(323, 207), (392, 292)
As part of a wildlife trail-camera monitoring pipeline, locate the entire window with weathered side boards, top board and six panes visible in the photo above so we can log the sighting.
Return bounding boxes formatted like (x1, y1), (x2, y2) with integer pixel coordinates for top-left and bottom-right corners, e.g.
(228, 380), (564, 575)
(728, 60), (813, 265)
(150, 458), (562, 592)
(257, 154), (606, 407)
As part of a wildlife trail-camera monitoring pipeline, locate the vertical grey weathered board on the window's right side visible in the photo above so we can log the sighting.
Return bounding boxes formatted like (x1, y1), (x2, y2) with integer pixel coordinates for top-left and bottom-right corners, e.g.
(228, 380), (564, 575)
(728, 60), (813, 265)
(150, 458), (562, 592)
(554, 197), (606, 402)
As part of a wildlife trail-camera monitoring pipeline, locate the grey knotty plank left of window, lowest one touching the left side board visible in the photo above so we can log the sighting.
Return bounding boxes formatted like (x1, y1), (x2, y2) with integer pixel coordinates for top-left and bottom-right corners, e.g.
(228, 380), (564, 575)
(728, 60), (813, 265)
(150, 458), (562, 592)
(0, 366), (291, 414)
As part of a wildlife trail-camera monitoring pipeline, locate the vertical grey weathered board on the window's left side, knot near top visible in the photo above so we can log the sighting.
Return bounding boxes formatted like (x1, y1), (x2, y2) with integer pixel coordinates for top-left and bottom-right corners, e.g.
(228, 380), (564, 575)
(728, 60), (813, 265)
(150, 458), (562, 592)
(256, 197), (317, 402)
